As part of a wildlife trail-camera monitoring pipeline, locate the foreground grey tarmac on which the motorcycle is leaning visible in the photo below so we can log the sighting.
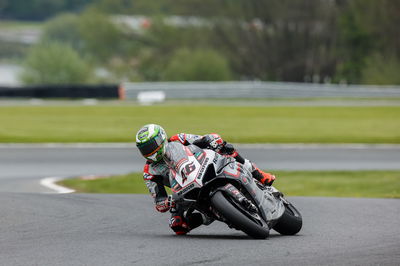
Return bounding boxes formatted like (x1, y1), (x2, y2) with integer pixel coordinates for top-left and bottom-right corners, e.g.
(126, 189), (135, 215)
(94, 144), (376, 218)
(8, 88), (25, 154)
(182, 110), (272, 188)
(0, 192), (400, 265)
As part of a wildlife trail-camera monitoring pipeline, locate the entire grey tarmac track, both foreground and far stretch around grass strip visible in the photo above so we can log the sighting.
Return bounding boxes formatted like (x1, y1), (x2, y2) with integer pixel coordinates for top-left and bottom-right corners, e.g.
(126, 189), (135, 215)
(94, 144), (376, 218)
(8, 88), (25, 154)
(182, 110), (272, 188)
(0, 144), (400, 265)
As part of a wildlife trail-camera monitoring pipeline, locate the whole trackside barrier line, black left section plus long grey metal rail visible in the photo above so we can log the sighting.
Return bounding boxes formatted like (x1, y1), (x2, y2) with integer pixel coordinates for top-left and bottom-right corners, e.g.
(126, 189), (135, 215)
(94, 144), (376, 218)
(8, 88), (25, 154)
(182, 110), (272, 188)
(0, 81), (400, 99)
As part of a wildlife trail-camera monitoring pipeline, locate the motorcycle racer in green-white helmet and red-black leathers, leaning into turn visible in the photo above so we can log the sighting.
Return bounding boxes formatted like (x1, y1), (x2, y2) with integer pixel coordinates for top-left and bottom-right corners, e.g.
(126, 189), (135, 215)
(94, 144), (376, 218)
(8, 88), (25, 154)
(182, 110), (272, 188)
(136, 124), (275, 235)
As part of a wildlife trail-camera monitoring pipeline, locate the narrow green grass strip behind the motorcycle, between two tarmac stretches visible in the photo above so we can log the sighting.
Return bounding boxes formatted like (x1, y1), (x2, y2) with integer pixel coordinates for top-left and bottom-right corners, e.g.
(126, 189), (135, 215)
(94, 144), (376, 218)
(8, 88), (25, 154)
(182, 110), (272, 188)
(60, 171), (400, 198)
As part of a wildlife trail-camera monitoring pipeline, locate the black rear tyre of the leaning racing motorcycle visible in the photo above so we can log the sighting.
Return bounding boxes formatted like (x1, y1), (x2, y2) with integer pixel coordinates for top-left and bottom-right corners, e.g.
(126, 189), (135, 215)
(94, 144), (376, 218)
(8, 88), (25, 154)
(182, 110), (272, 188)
(273, 204), (303, 235)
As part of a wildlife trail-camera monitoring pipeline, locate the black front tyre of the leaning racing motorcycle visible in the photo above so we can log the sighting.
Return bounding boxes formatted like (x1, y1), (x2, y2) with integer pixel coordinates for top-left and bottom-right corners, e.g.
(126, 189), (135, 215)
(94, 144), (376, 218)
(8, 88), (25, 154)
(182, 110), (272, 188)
(211, 191), (269, 239)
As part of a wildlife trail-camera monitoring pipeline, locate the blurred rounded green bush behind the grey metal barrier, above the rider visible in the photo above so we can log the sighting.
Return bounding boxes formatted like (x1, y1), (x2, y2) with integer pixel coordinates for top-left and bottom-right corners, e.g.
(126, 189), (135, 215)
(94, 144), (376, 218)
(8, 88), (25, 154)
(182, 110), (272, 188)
(163, 48), (231, 81)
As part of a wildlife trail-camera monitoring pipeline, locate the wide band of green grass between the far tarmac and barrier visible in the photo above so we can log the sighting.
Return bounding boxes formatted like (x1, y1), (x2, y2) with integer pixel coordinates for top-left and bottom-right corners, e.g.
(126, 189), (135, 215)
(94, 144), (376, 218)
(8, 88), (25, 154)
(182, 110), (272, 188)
(0, 105), (400, 143)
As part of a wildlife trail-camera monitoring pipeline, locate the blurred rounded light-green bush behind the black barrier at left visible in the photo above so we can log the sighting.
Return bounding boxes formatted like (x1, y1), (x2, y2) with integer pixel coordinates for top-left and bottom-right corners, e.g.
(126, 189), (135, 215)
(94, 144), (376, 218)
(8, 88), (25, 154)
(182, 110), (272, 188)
(21, 43), (91, 84)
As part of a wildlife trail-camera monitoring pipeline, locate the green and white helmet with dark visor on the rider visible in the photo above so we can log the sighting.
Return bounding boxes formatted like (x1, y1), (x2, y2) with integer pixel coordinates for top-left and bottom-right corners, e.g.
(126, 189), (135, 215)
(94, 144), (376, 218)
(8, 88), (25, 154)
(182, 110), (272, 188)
(136, 124), (168, 162)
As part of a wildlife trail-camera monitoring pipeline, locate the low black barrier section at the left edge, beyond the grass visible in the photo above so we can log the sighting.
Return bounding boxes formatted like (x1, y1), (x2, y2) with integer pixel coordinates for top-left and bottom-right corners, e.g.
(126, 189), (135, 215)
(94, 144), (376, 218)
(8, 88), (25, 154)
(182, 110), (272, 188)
(0, 85), (119, 98)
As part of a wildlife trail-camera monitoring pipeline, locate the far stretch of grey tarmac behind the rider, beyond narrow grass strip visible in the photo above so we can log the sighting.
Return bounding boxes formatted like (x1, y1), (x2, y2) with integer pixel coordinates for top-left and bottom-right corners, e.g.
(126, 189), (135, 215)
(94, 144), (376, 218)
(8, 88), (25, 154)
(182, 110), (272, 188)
(0, 144), (400, 192)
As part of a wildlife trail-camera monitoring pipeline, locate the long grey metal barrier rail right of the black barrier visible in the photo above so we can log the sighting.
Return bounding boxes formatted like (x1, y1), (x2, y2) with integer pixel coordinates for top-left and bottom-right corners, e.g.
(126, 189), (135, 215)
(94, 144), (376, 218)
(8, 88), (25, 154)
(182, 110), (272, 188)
(120, 81), (400, 99)
